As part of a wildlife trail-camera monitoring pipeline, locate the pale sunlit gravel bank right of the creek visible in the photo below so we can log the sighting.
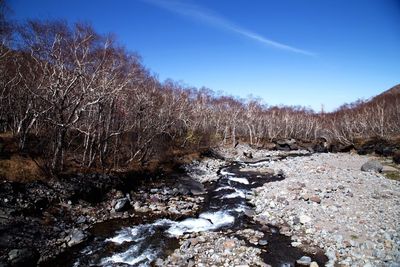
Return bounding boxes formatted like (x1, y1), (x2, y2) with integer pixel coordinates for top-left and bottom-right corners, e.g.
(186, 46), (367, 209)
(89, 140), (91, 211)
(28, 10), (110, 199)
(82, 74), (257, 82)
(252, 154), (400, 266)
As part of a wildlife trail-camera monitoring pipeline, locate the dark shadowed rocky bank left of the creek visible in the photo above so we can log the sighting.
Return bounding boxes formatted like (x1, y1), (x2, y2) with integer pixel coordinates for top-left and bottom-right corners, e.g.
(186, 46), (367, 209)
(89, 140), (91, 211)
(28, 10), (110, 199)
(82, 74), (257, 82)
(0, 175), (204, 266)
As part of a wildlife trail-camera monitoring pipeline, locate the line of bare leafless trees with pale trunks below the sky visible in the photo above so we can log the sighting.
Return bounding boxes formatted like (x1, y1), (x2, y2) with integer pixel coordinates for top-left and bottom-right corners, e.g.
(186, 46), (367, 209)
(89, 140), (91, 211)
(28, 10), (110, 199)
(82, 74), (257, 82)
(0, 18), (400, 172)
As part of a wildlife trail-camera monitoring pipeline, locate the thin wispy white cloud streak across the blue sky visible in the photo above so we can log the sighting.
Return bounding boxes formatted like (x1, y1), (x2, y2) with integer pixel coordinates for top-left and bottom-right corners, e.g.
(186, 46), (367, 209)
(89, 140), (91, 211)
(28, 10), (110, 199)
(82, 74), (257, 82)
(143, 0), (315, 56)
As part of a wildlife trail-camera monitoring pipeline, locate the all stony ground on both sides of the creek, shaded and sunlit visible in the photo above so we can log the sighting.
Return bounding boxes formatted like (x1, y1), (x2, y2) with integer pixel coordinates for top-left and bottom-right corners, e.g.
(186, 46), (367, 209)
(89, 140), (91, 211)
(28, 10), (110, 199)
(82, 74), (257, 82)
(0, 145), (400, 267)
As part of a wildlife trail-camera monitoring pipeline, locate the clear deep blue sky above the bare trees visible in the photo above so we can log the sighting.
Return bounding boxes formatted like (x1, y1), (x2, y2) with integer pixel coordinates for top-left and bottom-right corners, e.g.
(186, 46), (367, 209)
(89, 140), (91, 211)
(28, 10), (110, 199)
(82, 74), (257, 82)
(8, 0), (400, 111)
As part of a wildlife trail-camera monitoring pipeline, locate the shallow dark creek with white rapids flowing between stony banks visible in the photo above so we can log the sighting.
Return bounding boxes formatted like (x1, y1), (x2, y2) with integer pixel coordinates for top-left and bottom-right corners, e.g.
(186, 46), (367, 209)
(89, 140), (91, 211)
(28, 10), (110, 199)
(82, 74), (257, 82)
(55, 159), (324, 266)
